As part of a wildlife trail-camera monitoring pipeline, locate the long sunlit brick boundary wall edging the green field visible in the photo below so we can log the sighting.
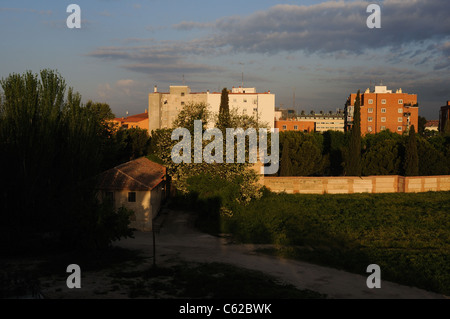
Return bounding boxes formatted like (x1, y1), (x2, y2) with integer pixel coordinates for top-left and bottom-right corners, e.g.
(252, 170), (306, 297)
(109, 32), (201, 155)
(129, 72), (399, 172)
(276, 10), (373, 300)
(260, 175), (450, 194)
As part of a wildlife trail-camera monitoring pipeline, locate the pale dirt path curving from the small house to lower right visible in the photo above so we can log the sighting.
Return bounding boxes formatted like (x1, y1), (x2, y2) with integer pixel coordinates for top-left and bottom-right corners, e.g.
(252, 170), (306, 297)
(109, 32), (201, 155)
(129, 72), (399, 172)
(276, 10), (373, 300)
(117, 210), (446, 299)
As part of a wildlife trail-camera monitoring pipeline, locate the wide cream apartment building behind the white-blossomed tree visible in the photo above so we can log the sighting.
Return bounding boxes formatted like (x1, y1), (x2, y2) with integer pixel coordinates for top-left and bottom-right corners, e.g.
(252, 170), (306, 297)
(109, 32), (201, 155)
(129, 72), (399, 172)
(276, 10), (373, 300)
(148, 86), (275, 131)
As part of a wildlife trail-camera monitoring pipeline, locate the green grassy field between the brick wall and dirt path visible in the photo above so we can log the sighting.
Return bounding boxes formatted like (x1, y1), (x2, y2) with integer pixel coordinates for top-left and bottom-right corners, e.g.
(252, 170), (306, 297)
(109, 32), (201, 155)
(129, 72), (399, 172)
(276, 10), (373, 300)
(220, 192), (450, 295)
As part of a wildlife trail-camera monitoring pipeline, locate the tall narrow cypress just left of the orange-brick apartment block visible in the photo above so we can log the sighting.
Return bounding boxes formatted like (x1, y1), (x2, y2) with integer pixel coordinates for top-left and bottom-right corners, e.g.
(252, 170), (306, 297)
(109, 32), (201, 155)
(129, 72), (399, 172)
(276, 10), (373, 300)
(346, 90), (361, 176)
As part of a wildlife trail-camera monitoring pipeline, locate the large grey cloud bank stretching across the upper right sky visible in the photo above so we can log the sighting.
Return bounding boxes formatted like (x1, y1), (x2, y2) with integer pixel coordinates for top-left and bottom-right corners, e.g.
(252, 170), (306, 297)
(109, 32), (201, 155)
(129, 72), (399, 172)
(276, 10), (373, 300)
(88, 0), (450, 82)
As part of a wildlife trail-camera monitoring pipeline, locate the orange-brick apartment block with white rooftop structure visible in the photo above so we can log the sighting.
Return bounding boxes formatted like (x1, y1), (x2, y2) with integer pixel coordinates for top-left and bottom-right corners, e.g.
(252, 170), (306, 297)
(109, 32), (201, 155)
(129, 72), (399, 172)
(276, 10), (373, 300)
(345, 86), (419, 135)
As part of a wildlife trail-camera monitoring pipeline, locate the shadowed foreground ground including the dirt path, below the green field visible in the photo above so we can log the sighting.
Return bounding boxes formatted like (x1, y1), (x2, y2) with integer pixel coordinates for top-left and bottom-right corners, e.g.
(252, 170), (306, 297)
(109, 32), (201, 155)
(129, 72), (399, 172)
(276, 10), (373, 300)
(2, 209), (446, 299)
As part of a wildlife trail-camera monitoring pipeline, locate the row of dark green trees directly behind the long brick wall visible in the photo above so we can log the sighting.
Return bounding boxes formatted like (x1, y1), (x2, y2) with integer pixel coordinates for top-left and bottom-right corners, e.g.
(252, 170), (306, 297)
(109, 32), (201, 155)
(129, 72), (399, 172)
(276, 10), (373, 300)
(278, 130), (450, 176)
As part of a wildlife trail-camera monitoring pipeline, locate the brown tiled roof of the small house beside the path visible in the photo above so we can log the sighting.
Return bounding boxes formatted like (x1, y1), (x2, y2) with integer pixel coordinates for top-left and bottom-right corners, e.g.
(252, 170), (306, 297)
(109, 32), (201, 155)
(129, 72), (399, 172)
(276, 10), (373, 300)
(97, 157), (166, 191)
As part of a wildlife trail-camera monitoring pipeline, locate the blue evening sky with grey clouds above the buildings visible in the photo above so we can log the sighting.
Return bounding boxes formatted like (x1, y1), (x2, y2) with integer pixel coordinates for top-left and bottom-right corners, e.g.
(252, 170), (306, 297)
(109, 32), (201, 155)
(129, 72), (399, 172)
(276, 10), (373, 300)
(0, 0), (450, 120)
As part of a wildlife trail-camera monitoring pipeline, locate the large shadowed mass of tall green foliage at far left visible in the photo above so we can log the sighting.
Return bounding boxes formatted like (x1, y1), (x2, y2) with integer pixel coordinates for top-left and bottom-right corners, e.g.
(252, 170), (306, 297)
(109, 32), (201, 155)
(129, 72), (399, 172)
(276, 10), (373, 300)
(0, 70), (133, 249)
